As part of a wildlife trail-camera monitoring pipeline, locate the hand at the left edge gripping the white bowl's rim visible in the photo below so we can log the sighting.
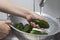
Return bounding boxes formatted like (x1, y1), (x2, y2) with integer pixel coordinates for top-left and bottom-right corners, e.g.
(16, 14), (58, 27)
(0, 20), (11, 39)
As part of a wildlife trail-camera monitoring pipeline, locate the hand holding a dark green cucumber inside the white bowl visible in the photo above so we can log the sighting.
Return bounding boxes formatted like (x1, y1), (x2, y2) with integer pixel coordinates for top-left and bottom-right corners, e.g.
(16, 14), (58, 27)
(26, 13), (47, 28)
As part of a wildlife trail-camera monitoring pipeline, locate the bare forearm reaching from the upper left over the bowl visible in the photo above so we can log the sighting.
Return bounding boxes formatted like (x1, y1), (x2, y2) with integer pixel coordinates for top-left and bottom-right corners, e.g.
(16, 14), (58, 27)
(0, 0), (32, 17)
